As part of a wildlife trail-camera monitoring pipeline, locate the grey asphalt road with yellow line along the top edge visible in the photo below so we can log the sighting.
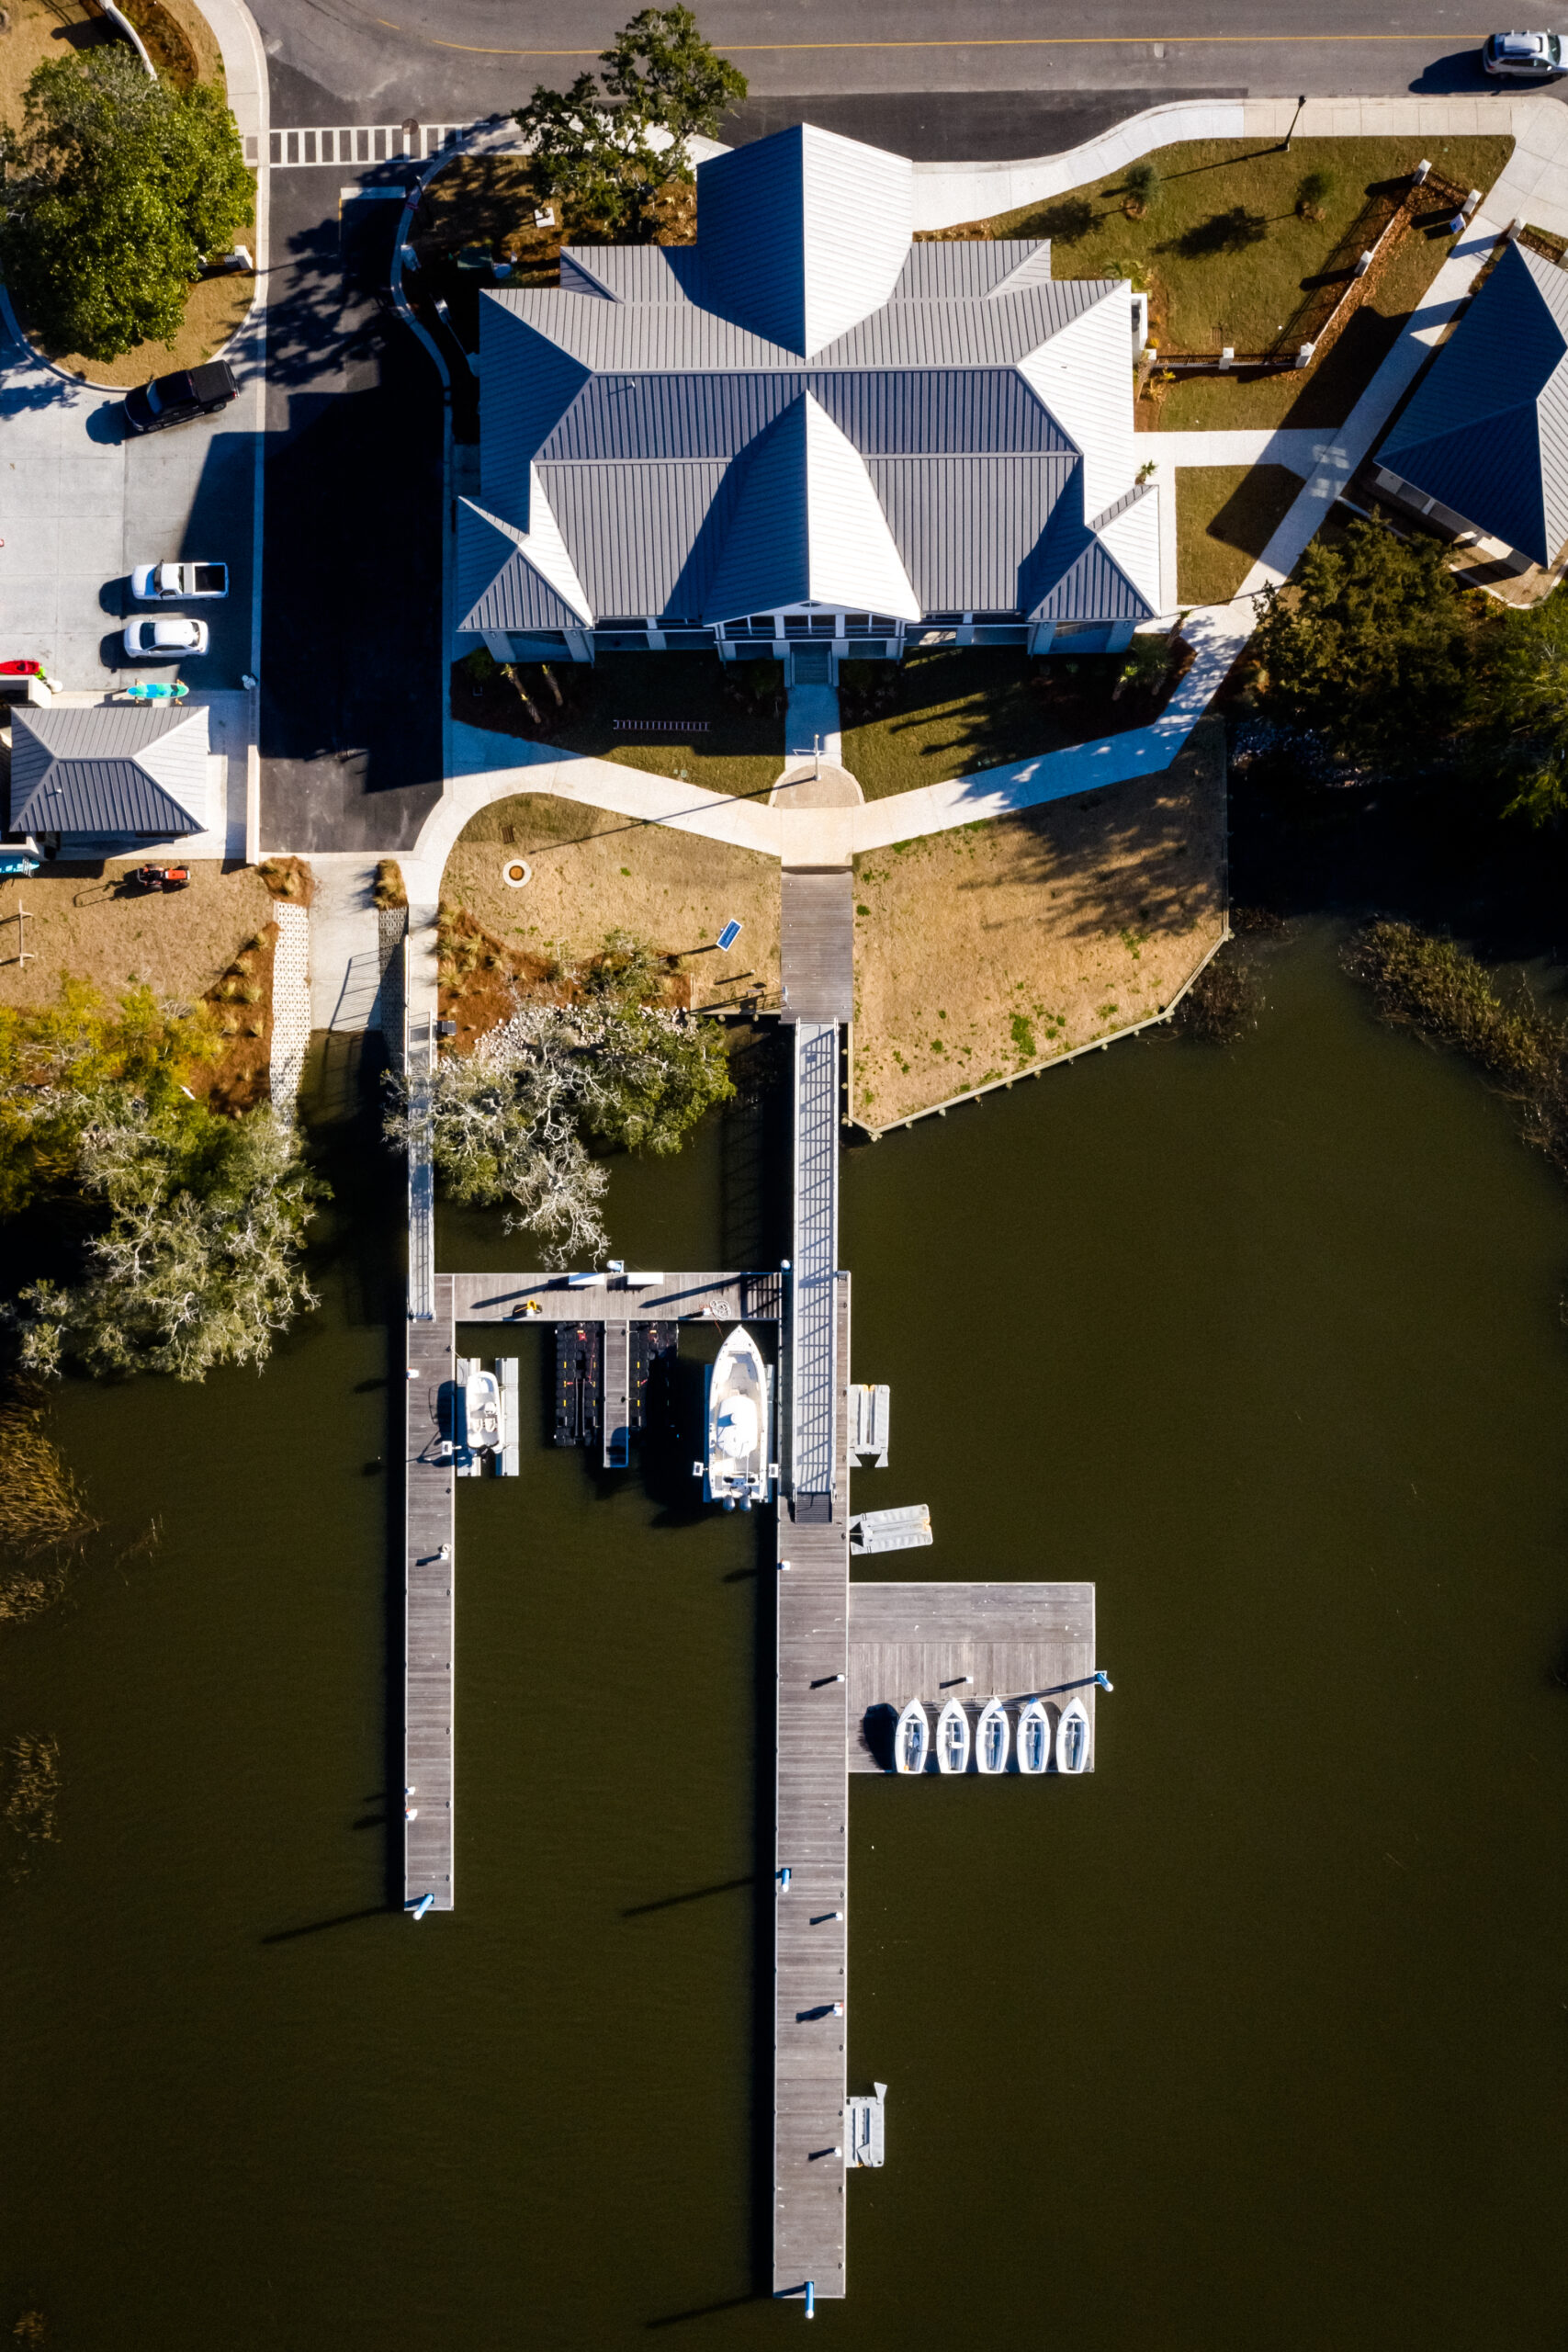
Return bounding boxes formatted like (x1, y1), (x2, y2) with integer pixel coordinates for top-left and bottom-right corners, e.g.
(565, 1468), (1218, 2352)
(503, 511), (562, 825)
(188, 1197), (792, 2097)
(256, 0), (1561, 130)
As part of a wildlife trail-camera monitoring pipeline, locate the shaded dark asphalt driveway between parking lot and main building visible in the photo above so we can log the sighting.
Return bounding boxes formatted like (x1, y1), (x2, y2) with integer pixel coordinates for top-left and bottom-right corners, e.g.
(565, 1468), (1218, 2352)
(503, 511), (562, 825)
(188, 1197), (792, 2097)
(261, 149), (442, 852)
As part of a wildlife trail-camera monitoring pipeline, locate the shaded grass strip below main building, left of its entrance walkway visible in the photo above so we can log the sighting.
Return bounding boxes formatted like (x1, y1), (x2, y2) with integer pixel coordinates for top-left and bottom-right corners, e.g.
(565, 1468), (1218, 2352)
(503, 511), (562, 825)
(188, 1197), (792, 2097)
(451, 654), (785, 795)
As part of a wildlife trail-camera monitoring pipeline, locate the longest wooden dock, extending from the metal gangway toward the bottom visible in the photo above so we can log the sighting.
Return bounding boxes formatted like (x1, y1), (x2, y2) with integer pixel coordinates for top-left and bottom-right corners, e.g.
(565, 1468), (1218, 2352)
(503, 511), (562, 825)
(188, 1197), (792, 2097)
(773, 1275), (849, 2296)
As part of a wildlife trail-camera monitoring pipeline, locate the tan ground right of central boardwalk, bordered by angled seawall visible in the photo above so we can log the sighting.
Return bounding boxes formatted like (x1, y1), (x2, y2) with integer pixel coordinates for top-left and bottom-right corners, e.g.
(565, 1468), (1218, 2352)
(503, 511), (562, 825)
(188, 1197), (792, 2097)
(853, 719), (1224, 1129)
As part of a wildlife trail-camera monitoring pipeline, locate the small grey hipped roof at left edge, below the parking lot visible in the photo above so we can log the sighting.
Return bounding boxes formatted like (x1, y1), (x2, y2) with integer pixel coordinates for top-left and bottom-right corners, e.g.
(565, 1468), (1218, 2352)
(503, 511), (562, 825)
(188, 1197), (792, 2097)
(12, 703), (209, 840)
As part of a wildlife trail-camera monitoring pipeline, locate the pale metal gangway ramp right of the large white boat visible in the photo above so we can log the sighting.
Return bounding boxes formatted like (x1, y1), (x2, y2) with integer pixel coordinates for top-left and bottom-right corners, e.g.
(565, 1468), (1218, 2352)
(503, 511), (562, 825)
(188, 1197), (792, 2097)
(787, 1021), (840, 1496)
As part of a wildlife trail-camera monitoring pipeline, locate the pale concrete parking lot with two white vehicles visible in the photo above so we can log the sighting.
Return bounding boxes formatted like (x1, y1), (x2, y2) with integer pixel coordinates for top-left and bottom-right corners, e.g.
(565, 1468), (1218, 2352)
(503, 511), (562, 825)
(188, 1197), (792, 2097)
(0, 310), (256, 692)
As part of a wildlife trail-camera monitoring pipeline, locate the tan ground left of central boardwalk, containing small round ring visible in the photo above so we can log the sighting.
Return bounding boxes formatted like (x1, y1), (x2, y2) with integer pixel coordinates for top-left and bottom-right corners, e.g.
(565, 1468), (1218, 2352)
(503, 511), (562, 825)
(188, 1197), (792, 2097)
(442, 793), (778, 1042)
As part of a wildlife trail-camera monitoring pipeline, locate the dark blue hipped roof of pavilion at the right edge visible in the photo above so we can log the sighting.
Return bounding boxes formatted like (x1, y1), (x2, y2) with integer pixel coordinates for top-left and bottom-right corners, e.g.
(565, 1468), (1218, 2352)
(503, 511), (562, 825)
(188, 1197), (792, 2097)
(1378, 244), (1568, 564)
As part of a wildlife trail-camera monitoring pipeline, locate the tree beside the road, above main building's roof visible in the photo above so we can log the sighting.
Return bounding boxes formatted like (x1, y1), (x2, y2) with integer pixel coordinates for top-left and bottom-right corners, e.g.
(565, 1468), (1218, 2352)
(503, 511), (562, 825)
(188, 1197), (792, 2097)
(514, 7), (745, 231)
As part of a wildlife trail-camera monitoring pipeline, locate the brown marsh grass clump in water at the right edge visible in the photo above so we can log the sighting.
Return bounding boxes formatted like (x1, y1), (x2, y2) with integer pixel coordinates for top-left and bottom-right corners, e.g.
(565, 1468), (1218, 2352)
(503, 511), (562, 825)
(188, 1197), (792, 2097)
(1345, 922), (1568, 1176)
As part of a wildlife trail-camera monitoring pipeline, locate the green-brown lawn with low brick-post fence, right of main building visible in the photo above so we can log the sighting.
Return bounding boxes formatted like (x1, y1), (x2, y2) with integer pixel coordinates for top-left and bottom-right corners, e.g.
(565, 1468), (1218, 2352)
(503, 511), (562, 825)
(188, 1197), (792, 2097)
(952, 139), (1514, 430)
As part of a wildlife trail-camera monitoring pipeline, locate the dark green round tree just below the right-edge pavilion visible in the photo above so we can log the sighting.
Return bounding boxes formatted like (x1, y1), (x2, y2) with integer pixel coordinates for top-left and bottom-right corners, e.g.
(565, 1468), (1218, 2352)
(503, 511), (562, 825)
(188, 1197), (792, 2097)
(1251, 522), (1472, 760)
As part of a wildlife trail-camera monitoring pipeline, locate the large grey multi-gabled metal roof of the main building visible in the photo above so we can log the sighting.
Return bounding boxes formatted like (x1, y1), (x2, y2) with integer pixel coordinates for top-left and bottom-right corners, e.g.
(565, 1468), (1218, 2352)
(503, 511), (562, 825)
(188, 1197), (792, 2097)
(458, 130), (1149, 630)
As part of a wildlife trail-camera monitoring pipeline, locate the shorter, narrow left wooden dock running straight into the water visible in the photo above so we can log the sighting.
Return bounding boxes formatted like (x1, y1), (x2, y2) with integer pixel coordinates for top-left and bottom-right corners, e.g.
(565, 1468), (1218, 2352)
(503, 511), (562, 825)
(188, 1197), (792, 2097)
(402, 1275), (456, 1910)
